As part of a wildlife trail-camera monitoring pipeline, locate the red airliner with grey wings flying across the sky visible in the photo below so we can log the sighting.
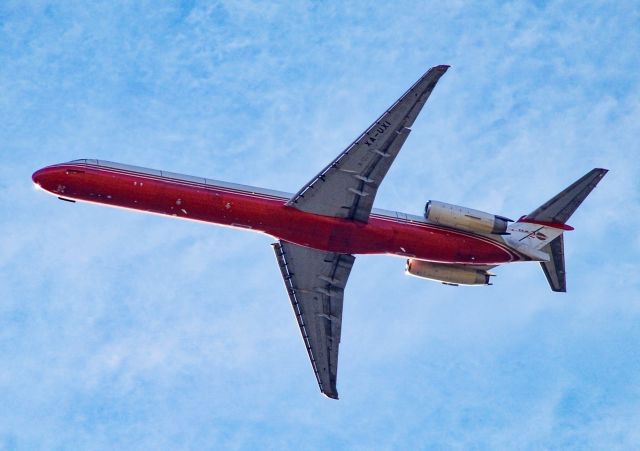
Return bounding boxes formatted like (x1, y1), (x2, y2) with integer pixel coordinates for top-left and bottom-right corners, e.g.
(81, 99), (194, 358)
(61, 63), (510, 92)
(32, 65), (607, 399)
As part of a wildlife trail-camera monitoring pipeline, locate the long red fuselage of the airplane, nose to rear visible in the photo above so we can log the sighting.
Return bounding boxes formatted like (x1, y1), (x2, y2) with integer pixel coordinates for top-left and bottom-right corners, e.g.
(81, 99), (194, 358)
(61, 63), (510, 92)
(33, 160), (523, 265)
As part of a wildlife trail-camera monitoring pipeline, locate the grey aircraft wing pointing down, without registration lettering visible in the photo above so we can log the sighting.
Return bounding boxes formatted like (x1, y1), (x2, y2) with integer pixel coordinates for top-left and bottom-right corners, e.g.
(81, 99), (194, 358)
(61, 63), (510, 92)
(273, 241), (355, 399)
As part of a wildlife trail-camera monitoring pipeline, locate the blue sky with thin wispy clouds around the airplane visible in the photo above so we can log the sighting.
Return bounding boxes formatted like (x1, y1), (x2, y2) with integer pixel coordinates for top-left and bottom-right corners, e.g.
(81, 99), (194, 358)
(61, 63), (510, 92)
(0, 1), (640, 450)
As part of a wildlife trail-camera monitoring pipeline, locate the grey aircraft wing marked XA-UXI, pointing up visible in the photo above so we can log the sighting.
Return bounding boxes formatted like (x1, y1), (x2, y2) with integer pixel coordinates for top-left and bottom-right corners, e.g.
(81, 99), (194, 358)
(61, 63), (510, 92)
(287, 66), (449, 223)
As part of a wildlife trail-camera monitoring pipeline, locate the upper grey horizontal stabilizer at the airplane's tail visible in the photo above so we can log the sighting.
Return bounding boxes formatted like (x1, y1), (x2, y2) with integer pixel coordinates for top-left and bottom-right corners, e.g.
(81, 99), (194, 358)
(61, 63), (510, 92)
(525, 169), (609, 224)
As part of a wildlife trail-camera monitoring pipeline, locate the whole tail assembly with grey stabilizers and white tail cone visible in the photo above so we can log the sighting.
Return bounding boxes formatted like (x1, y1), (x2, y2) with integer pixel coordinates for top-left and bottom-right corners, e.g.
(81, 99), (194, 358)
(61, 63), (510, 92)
(506, 169), (608, 292)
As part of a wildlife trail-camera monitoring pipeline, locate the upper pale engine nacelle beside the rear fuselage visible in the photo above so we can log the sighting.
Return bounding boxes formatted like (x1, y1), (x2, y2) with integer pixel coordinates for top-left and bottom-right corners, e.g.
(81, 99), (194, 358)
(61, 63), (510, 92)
(424, 200), (513, 235)
